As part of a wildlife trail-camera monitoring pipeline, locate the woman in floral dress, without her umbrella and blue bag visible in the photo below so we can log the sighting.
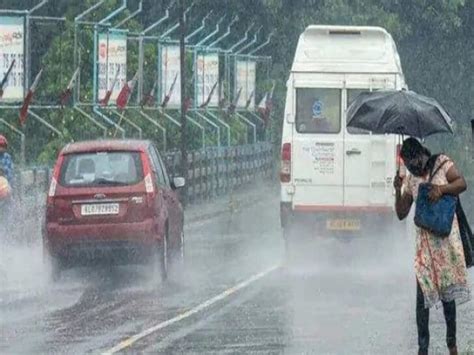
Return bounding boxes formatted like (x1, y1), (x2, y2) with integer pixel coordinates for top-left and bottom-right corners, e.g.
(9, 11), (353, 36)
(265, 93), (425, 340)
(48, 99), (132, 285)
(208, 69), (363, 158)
(394, 138), (470, 354)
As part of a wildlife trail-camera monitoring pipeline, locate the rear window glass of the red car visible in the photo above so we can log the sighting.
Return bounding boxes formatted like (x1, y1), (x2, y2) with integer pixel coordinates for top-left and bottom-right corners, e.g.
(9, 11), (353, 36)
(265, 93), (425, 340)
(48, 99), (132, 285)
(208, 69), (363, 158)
(59, 152), (143, 187)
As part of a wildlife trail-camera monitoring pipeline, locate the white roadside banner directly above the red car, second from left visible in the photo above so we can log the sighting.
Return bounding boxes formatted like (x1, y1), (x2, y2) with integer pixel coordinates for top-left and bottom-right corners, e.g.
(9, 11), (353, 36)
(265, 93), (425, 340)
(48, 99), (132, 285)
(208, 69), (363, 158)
(98, 33), (127, 104)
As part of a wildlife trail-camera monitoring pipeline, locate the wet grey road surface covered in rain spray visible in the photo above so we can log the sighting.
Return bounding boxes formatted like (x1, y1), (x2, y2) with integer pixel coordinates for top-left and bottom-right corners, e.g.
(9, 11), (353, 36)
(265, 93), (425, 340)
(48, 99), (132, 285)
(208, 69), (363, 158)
(0, 193), (474, 354)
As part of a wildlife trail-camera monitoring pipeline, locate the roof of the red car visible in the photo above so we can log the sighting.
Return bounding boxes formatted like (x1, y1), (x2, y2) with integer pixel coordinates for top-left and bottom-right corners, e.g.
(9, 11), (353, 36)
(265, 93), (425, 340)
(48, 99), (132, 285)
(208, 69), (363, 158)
(61, 139), (151, 155)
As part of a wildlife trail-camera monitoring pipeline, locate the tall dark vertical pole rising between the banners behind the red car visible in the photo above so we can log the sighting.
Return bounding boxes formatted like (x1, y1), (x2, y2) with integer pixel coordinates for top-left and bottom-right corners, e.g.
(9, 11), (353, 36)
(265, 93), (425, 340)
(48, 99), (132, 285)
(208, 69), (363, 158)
(178, 0), (188, 204)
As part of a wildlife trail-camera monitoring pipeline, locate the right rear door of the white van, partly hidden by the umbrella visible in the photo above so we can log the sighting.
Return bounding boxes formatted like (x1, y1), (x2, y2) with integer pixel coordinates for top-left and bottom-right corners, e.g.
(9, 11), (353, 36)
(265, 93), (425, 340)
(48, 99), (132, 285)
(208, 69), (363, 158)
(344, 88), (396, 207)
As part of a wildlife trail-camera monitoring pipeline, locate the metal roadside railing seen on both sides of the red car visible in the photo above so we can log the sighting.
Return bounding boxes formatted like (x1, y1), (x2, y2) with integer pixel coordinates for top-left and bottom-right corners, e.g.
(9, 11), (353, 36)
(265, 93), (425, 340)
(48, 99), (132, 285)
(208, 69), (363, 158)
(8, 142), (273, 239)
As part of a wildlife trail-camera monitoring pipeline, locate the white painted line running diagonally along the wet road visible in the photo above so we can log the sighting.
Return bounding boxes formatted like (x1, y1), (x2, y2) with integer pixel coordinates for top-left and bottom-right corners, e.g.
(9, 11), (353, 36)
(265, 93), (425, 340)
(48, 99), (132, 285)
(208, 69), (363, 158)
(102, 265), (280, 355)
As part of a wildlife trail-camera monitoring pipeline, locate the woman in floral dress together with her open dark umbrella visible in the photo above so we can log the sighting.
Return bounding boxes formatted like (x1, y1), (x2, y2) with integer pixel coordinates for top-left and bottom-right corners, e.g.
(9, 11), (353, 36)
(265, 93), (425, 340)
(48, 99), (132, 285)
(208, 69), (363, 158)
(347, 90), (471, 354)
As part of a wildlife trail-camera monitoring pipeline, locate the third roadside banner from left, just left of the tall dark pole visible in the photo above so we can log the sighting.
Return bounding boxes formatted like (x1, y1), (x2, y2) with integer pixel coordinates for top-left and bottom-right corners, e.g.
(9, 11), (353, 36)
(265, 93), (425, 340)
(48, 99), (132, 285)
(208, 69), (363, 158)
(160, 45), (181, 108)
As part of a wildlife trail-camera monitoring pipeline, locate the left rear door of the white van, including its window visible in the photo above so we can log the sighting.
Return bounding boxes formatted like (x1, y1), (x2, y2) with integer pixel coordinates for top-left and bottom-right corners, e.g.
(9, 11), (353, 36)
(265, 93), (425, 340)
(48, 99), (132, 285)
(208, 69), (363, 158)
(292, 87), (344, 210)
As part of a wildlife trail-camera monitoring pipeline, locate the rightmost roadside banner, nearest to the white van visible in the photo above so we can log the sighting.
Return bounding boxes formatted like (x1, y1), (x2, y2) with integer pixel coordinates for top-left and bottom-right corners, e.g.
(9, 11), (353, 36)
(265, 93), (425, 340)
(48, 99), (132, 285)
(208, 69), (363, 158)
(234, 60), (257, 109)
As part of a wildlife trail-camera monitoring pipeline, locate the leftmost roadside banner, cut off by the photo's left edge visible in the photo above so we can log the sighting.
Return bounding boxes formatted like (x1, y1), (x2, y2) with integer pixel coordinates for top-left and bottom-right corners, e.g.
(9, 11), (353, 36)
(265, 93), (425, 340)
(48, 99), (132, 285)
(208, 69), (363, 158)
(0, 16), (25, 101)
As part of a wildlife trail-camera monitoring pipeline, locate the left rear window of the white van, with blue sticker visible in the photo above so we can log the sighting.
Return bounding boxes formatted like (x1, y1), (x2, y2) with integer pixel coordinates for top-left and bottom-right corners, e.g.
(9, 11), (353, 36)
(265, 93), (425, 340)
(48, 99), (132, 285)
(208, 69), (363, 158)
(296, 88), (341, 134)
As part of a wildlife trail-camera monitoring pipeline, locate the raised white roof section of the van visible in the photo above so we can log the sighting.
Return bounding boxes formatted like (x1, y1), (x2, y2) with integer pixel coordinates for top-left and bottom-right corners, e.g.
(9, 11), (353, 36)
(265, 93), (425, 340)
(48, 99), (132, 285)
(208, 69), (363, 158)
(292, 25), (402, 74)
